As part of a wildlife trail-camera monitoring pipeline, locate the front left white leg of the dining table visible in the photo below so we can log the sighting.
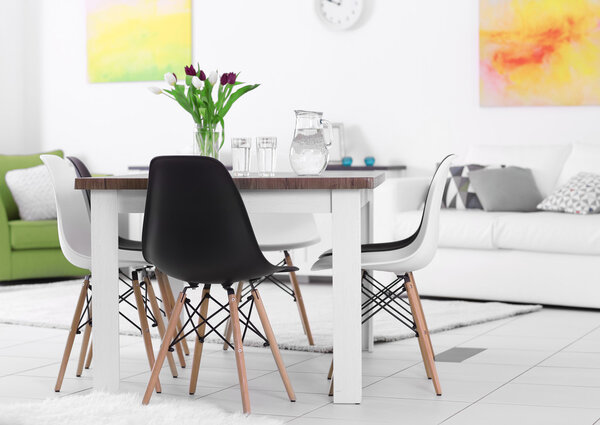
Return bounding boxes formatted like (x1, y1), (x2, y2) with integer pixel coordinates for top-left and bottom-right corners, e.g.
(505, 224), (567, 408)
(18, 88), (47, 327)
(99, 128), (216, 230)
(91, 190), (120, 392)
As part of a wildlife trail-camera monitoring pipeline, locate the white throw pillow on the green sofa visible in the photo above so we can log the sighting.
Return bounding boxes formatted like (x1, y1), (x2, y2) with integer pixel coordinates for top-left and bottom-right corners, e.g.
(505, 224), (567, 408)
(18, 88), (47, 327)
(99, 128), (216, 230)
(6, 165), (56, 221)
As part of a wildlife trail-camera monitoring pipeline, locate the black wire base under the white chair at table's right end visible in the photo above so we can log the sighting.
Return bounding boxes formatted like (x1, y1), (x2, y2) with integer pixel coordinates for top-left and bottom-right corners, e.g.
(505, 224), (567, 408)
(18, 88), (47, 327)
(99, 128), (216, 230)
(361, 271), (419, 336)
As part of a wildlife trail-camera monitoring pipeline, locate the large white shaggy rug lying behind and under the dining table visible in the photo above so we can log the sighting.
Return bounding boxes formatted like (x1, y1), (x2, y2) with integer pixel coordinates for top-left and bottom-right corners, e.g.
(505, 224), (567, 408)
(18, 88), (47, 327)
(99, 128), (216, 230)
(0, 281), (542, 352)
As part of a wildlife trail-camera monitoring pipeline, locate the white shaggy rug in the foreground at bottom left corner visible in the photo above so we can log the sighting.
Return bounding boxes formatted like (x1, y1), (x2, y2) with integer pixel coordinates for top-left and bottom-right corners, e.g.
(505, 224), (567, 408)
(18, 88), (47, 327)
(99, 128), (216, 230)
(0, 393), (283, 425)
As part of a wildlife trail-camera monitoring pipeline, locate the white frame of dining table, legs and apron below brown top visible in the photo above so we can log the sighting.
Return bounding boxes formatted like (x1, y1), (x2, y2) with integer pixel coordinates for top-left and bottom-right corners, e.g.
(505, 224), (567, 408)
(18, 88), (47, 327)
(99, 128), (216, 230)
(91, 189), (373, 404)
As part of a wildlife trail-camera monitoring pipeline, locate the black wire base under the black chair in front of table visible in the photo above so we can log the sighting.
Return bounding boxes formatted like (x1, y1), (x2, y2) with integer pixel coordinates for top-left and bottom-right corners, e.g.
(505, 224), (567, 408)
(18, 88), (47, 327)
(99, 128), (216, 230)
(169, 282), (269, 352)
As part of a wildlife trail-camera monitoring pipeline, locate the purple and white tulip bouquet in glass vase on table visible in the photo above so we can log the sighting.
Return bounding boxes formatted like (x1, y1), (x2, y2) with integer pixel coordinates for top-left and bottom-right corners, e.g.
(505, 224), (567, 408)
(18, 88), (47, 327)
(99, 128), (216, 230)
(150, 65), (259, 158)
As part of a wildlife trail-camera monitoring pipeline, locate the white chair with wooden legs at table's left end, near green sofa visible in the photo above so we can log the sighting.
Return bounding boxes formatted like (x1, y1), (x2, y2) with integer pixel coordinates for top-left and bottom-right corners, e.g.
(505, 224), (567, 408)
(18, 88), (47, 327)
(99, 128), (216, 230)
(40, 155), (177, 392)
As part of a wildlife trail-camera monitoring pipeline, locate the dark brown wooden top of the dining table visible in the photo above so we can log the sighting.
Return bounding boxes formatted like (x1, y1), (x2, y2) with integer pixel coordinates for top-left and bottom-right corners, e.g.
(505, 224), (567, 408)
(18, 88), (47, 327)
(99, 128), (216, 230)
(75, 171), (385, 190)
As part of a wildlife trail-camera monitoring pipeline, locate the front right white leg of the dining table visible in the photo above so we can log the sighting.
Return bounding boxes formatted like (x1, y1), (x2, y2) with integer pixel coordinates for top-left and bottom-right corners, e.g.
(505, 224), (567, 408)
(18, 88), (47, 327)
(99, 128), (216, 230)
(331, 190), (362, 403)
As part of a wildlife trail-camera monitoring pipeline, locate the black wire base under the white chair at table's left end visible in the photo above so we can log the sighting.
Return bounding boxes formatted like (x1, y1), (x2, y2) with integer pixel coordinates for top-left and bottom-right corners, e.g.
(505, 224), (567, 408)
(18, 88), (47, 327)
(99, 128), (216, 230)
(76, 269), (166, 335)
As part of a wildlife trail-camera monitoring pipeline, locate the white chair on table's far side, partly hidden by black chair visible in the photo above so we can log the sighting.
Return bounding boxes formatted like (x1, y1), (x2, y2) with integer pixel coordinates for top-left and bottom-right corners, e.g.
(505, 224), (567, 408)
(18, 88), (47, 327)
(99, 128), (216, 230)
(223, 214), (321, 350)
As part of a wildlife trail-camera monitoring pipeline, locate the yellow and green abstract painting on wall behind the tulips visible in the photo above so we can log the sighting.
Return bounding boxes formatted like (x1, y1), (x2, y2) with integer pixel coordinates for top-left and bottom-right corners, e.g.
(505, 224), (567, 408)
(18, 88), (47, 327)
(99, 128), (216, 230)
(86, 0), (192, 83)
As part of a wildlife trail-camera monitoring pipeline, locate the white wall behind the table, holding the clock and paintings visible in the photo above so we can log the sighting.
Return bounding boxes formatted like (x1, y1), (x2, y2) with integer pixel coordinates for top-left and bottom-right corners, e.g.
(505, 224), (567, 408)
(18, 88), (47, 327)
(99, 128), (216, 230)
(29, 0), (600, 172)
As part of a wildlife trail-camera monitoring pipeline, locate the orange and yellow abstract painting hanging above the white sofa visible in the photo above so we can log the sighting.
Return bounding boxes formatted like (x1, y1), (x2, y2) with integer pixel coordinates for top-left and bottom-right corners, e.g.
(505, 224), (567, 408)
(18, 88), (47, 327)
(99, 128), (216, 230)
(479, 0), (600, 106)
